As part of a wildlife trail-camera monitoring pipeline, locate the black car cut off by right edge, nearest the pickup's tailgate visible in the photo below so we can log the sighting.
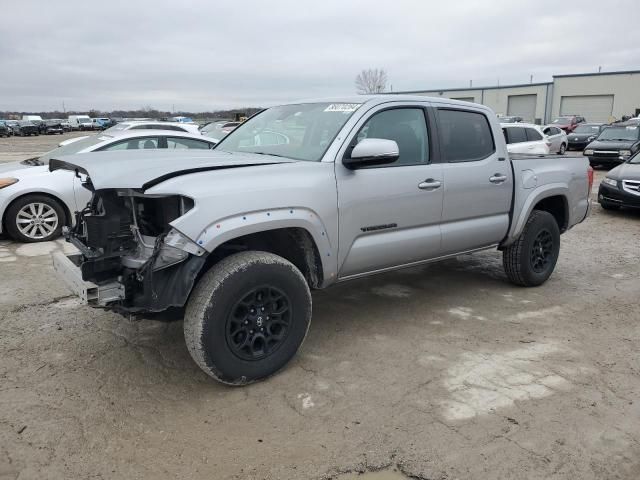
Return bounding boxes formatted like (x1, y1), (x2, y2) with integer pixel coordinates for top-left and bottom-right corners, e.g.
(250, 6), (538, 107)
(598, 154), (640, 210)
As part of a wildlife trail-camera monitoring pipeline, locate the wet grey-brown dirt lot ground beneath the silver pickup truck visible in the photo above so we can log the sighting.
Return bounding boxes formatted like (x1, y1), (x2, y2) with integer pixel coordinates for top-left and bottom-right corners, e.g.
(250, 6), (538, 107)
(0, 134), (640, 480)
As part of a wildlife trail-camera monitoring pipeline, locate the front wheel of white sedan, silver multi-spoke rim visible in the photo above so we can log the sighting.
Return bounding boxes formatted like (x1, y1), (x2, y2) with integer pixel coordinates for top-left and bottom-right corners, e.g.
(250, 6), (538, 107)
(5, 195), (66, 243)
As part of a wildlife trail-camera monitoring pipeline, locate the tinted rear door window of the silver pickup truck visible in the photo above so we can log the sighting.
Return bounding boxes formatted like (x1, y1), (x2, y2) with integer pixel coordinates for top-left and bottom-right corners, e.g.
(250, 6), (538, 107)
(438, 108), (496, 162)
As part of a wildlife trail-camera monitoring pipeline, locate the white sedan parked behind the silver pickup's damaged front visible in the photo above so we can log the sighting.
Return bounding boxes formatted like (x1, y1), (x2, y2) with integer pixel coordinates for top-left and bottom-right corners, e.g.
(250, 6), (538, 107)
(0, 130), (216, 242)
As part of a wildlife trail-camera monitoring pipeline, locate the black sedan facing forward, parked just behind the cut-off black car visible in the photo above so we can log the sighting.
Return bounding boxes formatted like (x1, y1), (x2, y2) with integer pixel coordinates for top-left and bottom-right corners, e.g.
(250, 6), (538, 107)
(582, 126), (640, 167)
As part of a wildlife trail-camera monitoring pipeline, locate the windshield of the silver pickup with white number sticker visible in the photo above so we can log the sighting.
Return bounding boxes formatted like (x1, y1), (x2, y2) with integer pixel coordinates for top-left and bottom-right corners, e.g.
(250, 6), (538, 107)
(217, 103), (362, 162)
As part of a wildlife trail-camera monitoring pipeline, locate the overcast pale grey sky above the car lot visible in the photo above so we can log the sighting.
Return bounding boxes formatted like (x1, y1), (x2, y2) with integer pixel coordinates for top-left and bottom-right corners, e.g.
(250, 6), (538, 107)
(0, 0), (640, 111)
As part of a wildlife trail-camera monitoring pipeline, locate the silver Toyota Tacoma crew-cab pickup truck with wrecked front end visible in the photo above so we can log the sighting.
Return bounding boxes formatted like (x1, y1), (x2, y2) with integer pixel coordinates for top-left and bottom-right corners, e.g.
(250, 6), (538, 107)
(50, 95), (593, 385)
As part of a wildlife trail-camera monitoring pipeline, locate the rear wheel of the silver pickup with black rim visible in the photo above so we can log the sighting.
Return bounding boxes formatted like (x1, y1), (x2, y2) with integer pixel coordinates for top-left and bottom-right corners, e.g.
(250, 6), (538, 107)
(502, 210), (560, 287)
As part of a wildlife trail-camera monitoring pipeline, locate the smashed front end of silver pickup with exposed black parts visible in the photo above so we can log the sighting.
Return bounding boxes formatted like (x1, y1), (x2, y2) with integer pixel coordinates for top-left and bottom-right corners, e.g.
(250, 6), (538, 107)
(54, 189), (206, 314)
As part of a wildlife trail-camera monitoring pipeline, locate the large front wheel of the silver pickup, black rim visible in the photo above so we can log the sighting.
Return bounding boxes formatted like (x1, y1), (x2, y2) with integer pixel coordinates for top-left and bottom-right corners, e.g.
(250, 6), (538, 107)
(184, 251), (311, 385)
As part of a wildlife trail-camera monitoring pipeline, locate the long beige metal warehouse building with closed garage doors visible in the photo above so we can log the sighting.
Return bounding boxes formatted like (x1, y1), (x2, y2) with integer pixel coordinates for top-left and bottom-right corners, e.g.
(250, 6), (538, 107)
(393, 70), (640, 123)
